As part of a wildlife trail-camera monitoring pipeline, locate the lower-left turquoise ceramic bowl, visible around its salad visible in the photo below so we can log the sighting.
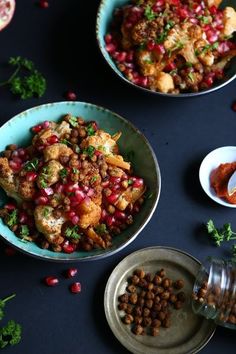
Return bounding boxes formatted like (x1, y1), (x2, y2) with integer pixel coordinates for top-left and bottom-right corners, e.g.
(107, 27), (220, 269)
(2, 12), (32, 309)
(0, 102), (161, 261)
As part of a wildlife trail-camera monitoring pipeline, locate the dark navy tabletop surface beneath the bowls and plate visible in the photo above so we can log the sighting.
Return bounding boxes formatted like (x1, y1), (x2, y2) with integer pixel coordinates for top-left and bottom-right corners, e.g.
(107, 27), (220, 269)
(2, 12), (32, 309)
(0, 0), (236, 354)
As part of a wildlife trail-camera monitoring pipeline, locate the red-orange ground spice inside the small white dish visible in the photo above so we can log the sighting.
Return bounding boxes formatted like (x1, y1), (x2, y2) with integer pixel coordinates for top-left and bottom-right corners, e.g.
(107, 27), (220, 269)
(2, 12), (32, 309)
(210, 162), (236, 204)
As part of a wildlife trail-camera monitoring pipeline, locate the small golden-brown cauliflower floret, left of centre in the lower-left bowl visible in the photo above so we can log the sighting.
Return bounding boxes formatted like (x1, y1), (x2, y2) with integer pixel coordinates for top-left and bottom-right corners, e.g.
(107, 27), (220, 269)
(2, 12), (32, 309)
(37, 160), (63, 188)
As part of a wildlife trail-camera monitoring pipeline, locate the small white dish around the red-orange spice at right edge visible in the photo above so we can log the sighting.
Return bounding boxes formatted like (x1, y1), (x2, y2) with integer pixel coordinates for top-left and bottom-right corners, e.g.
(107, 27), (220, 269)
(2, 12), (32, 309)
(199, 146), (236, 208)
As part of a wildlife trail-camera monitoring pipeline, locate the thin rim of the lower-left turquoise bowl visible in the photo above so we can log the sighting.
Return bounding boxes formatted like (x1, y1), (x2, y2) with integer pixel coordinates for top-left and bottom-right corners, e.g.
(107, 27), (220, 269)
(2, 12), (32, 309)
(0, 101), (162, 263)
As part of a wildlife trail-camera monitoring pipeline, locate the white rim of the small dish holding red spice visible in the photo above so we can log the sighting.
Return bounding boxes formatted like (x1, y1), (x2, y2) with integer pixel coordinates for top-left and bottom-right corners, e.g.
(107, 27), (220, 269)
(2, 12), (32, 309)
(199, 145), (236, 208)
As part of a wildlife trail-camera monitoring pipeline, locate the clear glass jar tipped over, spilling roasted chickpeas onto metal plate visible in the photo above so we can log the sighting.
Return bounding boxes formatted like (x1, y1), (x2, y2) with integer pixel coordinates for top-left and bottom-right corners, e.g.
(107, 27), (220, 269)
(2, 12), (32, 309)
(192, 257), (236, 329)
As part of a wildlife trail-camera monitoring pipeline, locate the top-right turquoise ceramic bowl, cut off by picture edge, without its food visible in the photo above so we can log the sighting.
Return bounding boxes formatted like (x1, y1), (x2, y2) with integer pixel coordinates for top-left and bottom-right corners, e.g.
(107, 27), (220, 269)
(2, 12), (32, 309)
(96, 0), (236, 97)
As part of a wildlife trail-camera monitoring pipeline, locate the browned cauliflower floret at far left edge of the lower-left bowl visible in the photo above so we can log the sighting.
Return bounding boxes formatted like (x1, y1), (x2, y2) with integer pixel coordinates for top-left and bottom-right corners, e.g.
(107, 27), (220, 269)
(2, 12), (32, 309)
(0, 157), (17, 198)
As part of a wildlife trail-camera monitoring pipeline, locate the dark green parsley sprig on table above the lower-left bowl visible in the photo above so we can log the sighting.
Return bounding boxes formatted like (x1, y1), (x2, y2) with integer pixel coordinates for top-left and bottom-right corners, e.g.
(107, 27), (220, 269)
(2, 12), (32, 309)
(0, 57), (46, 99)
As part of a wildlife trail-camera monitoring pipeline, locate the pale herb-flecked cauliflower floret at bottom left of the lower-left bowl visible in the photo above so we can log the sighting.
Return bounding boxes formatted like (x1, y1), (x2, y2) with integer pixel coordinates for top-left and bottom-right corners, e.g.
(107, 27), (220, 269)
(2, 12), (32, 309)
(34, 205), (66, 245)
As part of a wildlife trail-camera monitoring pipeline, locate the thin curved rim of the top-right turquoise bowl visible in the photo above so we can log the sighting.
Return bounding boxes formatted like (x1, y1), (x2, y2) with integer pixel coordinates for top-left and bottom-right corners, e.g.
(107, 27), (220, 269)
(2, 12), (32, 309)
(95, 0), (236, 98)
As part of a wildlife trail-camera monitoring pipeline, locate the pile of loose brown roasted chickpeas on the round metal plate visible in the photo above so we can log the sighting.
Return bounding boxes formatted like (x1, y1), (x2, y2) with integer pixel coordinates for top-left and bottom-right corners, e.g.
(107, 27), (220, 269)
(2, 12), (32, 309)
(118, 268), (186, 337)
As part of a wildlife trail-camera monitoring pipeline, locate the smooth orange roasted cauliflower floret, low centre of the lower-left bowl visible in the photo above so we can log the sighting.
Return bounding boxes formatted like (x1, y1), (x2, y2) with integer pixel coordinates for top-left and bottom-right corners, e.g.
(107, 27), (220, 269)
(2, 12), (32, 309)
(77, 200), (101, 229)
